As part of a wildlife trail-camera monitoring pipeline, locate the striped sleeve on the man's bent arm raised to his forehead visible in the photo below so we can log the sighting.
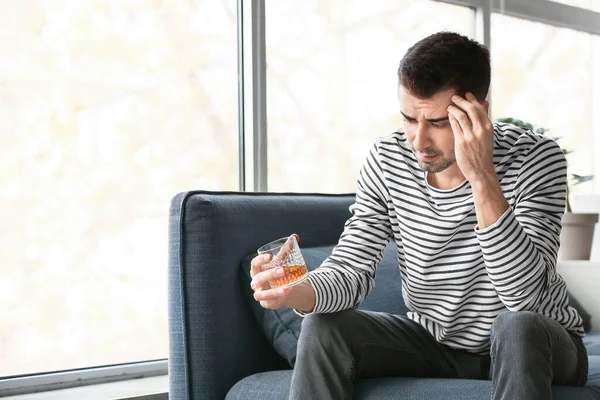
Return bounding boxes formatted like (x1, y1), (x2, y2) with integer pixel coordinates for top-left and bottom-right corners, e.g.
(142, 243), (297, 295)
(476, 139), (567, 311)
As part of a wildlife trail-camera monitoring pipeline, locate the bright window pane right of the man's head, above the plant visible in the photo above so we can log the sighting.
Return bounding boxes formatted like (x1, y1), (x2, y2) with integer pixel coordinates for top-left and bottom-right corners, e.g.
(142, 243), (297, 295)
(491, 14), (600, 193)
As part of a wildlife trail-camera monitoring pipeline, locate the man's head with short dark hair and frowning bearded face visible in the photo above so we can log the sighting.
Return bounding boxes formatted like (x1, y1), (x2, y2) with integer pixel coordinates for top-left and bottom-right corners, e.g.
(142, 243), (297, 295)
(398, 32), (491, 173)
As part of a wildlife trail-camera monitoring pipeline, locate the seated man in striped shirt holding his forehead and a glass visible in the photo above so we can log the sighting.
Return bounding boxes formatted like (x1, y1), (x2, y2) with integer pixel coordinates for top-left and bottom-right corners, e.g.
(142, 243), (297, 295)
(251, 32), (587, 400)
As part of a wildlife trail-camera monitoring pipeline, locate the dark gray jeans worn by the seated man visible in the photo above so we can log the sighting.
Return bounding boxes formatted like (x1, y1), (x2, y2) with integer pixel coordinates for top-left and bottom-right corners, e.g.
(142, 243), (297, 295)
(290, 310), (587, 400)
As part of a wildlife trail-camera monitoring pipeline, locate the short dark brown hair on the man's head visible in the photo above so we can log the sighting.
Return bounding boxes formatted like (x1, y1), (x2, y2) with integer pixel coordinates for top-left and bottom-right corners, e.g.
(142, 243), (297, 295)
(398, 32), (491, 101)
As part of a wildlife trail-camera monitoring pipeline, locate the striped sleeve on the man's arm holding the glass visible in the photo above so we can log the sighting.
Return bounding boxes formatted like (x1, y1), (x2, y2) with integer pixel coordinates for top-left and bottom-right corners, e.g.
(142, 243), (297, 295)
(299, 143), (391, 315)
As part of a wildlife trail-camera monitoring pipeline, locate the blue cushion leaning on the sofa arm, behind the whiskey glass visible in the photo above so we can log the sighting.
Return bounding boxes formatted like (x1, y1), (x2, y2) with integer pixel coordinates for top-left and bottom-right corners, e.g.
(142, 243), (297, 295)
(241, 239), (408, 366)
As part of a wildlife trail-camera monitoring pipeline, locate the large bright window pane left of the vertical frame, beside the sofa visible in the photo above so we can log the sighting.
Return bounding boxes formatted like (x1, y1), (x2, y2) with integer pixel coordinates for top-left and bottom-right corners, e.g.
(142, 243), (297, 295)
(0, 0), (238, 376)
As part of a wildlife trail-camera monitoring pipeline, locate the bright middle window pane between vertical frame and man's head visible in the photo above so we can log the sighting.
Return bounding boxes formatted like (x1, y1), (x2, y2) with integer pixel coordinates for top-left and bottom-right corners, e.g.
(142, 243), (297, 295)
(265, 0), (474, 192)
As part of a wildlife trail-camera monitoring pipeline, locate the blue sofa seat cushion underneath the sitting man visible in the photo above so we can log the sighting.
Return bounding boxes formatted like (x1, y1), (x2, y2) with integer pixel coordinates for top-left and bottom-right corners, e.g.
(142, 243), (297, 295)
(226, 366), (600, 400)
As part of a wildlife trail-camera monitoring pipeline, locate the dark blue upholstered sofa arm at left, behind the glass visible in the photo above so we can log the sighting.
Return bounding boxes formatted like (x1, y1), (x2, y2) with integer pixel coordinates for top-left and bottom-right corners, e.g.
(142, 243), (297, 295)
(168, 191), (354, 400)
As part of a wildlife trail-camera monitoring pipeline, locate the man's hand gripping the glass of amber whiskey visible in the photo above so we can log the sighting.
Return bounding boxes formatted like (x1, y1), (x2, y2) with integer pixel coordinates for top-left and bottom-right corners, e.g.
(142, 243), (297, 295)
(250, 234), (316, 312)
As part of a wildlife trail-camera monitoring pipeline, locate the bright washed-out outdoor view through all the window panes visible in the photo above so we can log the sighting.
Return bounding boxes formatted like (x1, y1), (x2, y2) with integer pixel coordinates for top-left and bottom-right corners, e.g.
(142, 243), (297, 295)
(0, 0), (600, 377)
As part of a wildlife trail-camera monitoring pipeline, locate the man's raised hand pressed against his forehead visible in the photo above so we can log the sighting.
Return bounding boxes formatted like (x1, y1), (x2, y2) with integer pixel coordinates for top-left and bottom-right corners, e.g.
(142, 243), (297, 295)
(448, 93), (495, 185)
